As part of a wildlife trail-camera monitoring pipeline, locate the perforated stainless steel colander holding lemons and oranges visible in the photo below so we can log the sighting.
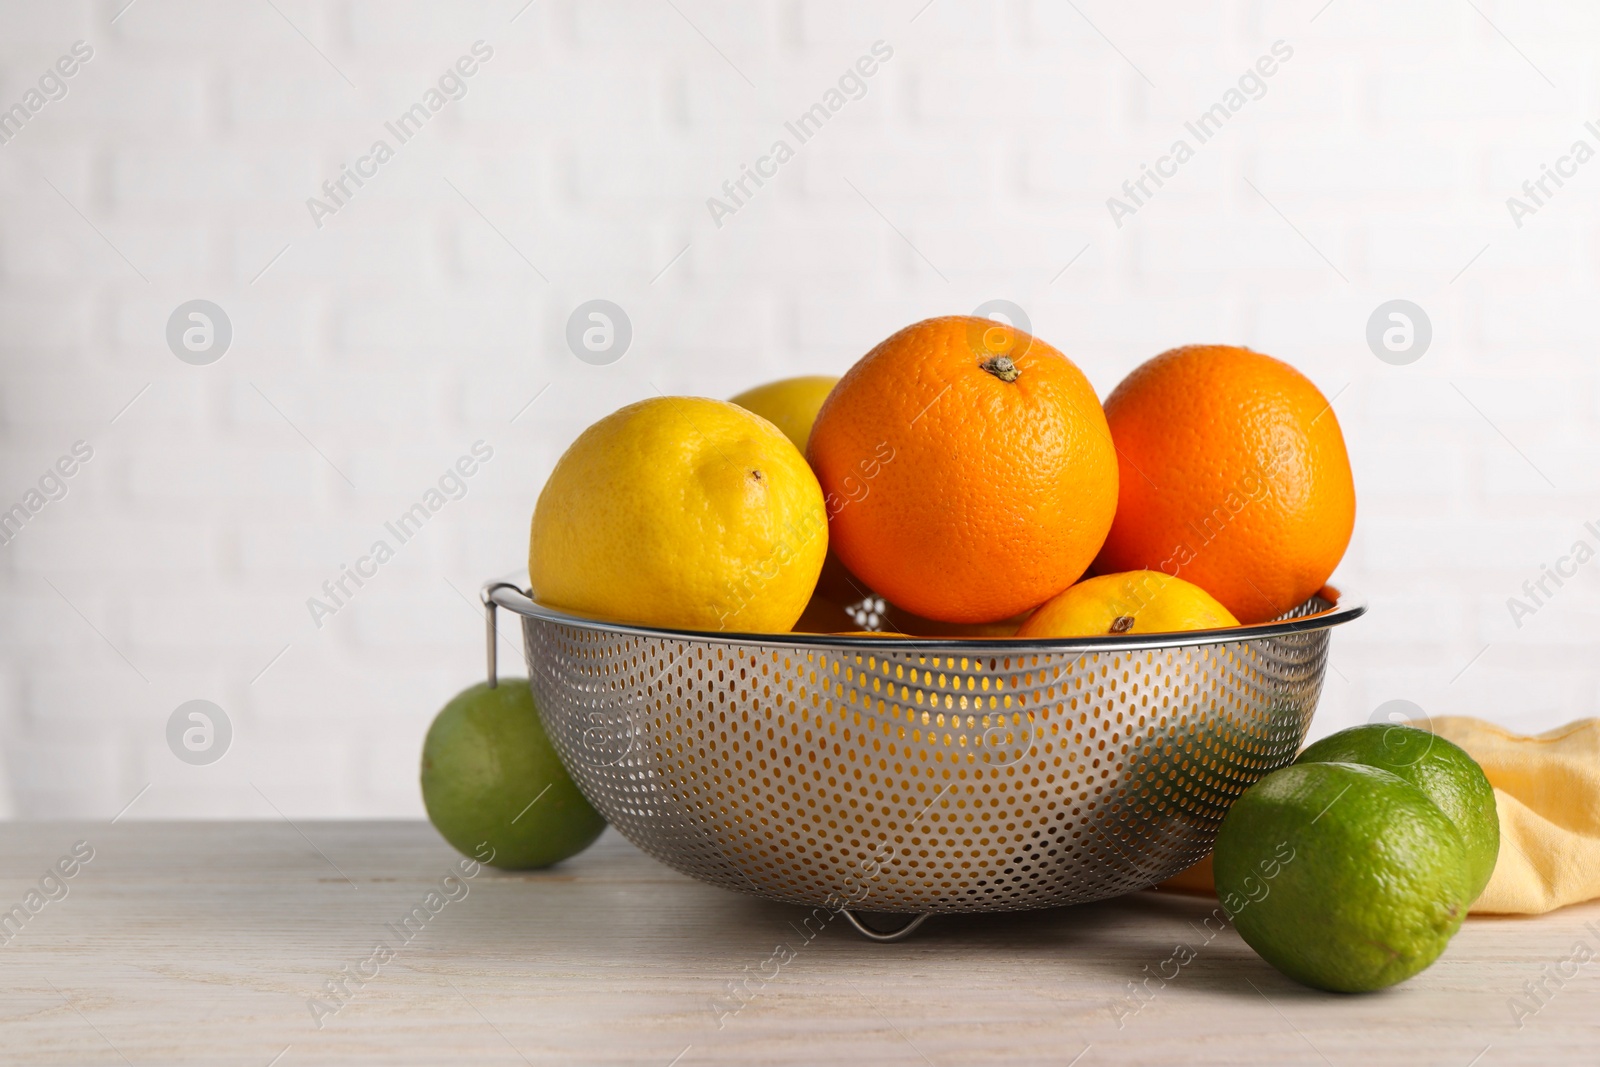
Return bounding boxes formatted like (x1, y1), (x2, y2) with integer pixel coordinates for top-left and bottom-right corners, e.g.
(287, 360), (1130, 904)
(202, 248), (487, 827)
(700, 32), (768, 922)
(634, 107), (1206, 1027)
(483, 582), (1365, 940)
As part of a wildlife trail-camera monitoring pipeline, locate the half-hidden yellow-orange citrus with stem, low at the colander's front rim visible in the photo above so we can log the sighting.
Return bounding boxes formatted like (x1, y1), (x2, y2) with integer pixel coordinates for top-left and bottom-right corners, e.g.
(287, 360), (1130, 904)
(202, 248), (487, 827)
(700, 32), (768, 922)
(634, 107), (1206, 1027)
(1016, 571), (1238, 637)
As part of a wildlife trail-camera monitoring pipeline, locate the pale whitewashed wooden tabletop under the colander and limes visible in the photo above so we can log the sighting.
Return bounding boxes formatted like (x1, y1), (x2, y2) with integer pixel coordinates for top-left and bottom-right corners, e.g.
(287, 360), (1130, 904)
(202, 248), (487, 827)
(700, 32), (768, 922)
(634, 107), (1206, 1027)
(0, 822), (1600, 1067)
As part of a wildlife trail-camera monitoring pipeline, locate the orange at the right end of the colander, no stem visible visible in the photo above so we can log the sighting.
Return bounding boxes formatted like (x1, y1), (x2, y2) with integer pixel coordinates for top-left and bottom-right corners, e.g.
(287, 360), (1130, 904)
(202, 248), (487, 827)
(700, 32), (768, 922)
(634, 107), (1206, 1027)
(1094, 344), (1355, 624)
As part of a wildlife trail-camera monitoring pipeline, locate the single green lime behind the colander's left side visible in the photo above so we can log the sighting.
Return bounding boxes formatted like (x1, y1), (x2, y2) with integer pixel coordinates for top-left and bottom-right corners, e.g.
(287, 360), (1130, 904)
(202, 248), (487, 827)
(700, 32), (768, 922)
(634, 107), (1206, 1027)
(422, 678), (605, 870)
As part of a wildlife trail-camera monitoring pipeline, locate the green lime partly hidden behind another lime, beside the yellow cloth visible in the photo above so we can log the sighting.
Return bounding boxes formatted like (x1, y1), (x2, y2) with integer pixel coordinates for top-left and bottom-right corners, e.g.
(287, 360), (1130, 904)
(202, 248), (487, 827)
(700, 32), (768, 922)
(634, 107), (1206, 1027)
(1294, 723), (1499, 902)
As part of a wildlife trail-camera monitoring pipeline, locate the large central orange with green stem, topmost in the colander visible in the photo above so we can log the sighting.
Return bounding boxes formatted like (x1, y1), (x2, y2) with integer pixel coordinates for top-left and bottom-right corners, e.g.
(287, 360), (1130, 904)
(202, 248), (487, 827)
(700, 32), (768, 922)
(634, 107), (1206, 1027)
(808, 315), (1117, 622)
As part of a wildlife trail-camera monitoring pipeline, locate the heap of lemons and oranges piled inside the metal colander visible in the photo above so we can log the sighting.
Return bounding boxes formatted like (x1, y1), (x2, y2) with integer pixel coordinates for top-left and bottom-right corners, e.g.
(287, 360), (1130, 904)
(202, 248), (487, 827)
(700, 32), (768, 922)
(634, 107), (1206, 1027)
(528, 315), (1355, 638)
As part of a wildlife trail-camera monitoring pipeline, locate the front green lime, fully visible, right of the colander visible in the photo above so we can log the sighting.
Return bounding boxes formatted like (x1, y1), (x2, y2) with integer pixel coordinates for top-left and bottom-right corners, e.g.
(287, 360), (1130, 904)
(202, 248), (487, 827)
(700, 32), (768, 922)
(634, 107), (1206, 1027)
(1213, 763), (1470, 993)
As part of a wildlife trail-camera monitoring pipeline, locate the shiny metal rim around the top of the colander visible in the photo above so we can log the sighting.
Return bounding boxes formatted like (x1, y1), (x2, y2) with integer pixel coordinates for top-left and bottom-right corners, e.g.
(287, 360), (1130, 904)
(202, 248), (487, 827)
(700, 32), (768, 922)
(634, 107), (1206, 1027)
(480, 581), (1366, 656)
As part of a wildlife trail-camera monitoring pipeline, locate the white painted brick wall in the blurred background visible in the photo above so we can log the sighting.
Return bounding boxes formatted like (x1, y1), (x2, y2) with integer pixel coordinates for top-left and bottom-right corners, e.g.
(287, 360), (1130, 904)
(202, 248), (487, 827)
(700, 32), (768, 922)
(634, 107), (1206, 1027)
(0, 0), (1600, 817)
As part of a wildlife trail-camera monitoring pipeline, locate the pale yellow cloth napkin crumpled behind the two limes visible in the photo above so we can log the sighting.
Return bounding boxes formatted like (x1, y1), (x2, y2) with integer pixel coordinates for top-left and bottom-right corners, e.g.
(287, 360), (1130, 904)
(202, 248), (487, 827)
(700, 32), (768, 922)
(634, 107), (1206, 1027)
(1162, 715), (1600, 915)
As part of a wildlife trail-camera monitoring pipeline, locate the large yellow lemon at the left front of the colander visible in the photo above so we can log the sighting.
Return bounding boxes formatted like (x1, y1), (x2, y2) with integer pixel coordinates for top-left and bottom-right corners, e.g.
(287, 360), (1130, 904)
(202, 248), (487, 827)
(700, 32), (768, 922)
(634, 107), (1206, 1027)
(528, 397), (827, 633)
